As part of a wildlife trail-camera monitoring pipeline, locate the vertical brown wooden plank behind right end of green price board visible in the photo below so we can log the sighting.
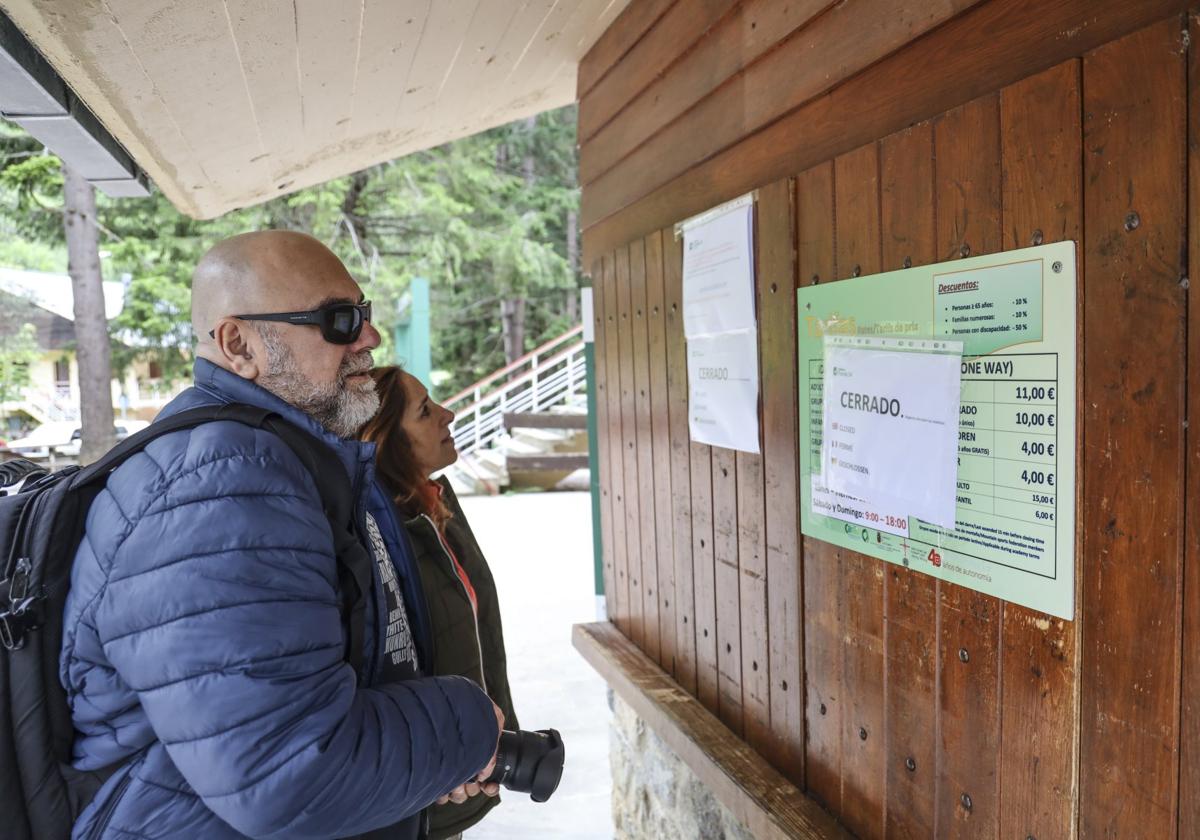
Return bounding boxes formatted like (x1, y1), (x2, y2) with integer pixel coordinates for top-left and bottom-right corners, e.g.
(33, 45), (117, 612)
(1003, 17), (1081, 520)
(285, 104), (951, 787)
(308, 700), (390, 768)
(1000, 60), (1085, 838)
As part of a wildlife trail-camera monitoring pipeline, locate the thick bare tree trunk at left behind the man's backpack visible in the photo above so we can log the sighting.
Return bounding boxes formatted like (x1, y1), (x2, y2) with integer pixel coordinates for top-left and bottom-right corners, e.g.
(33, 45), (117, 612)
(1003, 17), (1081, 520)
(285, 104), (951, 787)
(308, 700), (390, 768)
(62, 164), (114, 463)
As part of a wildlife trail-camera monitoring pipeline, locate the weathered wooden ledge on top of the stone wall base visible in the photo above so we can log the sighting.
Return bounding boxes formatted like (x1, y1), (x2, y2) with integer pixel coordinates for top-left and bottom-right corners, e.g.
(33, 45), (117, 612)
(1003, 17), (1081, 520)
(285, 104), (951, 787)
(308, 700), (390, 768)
(571, 623), (852, 840)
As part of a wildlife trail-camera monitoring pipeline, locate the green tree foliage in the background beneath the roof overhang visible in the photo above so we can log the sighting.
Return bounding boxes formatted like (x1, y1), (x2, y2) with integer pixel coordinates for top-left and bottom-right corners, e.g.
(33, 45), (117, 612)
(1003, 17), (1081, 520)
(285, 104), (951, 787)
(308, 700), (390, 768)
(0, 107), (578, 395)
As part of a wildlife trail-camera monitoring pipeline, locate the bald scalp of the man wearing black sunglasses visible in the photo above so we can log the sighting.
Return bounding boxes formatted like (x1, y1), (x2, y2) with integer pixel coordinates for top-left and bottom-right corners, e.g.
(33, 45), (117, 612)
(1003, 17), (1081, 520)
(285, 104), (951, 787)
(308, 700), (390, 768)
(192, 230), (353, 347)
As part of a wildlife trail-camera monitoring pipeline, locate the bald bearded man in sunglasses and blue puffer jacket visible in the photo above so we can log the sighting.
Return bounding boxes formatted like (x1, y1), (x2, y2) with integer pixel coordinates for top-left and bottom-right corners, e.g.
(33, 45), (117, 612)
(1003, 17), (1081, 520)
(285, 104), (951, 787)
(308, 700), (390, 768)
(61, 232), (503, 840)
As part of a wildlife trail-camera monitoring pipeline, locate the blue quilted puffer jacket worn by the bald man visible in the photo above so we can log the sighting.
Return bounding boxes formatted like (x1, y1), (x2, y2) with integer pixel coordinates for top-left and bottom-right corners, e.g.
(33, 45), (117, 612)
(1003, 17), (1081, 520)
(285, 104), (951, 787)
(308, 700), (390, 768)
(61, 360), (497, 840)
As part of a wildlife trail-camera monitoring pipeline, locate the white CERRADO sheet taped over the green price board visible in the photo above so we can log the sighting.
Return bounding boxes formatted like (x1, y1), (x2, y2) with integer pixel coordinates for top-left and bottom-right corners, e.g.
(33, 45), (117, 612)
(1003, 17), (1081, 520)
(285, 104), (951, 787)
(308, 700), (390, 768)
(821, 336), (962, 530)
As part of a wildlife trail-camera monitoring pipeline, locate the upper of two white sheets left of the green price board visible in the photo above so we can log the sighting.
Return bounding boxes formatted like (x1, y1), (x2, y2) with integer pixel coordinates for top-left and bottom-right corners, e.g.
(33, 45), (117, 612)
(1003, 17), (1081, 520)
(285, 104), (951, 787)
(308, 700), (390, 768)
(683, 200), (755, 340)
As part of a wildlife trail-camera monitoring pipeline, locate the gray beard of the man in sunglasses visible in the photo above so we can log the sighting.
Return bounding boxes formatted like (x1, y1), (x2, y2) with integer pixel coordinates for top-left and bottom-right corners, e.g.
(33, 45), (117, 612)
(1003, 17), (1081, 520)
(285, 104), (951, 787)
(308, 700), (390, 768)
(258, 324), (379, 438)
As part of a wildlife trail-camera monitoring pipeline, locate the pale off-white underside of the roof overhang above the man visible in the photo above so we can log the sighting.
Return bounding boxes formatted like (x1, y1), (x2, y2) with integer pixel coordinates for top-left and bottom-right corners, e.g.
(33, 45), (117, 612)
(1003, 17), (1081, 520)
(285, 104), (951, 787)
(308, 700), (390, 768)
(0, 0), (629, 218)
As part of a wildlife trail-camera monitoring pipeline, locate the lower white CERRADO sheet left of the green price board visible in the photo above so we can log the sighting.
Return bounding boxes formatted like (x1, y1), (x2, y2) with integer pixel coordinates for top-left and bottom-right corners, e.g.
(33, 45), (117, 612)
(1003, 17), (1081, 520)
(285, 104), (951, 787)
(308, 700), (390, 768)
(688, 330), (758, 452)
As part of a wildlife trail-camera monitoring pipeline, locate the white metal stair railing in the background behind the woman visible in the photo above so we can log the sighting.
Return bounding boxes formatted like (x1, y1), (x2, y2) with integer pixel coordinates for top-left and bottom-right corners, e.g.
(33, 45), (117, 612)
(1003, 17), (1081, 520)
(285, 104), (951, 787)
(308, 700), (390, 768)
(446, 328), (587, 455)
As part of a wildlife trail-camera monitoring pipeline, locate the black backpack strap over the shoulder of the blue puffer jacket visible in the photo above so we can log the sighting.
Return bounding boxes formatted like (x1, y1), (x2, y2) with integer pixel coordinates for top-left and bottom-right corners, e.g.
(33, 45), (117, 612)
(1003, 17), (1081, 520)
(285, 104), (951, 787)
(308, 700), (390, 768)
(71, 403), (372, 679)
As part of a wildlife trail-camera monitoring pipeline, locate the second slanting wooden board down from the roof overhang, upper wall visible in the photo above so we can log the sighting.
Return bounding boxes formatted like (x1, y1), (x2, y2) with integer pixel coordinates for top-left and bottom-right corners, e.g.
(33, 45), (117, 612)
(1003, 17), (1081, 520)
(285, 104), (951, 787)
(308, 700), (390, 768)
(578, 0), (737, 143)
